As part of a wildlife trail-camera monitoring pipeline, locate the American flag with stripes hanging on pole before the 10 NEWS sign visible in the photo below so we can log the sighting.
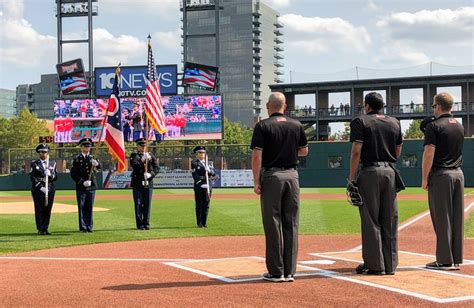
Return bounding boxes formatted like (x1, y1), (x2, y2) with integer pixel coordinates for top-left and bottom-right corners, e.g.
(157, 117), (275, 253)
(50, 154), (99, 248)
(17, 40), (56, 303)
(145, 37), (166, 134)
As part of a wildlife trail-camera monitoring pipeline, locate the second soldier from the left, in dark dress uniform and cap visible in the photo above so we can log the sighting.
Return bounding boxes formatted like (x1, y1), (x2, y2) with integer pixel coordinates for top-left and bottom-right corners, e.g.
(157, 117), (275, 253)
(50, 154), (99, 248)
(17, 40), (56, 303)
(71, 138), (101, 233)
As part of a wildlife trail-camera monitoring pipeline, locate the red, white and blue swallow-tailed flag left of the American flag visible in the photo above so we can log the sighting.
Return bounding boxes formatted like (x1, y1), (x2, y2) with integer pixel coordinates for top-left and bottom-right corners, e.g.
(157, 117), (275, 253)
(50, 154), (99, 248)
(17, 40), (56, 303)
(105, 65), (127, 173)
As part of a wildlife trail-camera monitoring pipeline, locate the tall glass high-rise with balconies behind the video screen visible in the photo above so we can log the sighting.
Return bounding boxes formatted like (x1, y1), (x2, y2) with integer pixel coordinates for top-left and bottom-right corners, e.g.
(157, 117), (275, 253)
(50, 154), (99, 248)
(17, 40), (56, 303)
(184, 0), (283, 126)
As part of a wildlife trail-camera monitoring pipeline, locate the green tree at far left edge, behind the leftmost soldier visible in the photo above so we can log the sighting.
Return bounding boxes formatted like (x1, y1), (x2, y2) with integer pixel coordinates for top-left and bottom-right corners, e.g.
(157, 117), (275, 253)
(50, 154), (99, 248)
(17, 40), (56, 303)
(0, 107), (52, 149)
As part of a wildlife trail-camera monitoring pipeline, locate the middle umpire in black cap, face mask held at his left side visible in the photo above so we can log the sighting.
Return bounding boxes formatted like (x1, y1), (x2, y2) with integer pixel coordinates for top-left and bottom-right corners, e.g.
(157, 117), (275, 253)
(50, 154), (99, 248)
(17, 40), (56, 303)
(349, 92), (402, 275)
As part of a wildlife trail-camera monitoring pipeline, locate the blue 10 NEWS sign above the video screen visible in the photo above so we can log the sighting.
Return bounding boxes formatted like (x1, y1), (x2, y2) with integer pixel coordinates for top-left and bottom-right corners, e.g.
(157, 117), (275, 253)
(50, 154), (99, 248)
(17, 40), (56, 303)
(95, 64), (178, 97)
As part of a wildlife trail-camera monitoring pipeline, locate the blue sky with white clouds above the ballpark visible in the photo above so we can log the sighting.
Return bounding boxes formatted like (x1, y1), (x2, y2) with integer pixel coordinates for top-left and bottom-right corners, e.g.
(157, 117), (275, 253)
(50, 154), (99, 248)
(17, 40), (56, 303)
(0, 0), (474, 130)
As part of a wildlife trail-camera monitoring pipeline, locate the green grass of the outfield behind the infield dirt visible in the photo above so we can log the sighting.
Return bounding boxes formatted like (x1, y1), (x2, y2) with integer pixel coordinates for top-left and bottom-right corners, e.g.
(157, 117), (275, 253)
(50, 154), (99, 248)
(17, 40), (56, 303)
(0, 188), (474, 254)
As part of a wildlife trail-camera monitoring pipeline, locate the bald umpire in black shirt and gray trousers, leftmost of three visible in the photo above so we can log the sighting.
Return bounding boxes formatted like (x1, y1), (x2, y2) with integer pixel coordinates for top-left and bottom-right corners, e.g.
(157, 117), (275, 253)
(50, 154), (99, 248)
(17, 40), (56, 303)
(250, 92), (308, 282)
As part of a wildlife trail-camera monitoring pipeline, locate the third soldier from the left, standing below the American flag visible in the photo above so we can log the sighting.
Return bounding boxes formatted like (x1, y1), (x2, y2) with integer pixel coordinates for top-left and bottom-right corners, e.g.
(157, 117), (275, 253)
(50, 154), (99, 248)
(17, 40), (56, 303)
(130, 138), (160, 230)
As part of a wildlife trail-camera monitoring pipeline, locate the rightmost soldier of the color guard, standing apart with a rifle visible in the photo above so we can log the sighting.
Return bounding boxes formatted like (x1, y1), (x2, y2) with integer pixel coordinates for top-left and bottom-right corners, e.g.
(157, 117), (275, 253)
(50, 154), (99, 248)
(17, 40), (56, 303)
(191, 146), (216, 228)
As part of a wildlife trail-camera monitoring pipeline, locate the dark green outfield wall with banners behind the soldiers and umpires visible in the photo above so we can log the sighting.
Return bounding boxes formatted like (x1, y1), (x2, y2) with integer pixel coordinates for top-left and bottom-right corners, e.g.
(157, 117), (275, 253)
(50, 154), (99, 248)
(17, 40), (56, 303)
(0, 138), (474, 190)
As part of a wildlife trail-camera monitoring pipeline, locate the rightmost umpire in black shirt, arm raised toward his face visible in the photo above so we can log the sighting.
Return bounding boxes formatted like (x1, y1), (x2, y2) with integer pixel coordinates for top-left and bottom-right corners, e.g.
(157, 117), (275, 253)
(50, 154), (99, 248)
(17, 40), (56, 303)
(421, 92), (464, 270)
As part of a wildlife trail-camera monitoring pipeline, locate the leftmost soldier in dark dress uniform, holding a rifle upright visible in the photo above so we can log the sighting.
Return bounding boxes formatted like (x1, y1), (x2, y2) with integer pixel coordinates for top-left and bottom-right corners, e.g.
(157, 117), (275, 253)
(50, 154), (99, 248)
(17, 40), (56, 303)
(30, 143), (58, 235)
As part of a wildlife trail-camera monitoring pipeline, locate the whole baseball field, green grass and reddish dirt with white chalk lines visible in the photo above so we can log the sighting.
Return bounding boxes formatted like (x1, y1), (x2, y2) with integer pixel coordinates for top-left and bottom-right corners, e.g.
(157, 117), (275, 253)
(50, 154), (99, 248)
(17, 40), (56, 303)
(0, 188), (474, 307)
